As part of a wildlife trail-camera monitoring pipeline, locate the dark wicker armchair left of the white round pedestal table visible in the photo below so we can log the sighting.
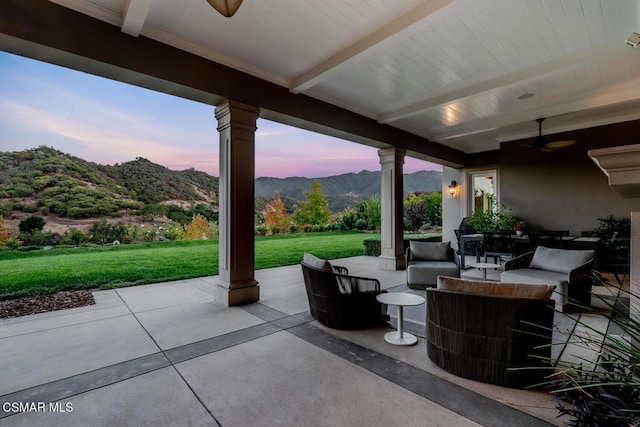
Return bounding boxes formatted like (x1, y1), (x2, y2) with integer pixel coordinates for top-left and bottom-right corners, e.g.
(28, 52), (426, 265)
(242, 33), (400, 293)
(301, 253), (388, 329)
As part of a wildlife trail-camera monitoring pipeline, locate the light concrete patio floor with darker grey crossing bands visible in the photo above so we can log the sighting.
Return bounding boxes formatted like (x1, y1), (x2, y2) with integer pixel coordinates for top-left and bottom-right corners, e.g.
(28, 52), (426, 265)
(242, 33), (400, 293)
(0, 256), (606, 426)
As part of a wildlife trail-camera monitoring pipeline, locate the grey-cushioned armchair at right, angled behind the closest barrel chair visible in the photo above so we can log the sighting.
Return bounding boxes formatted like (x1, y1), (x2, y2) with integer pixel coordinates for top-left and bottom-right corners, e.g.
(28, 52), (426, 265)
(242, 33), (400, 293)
(500, 246), (595, 311)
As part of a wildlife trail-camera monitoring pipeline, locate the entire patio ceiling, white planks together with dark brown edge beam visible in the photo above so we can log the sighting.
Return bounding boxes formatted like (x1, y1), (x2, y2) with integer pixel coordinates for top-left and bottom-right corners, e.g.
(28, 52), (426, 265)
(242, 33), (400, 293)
(0, 0), (640, 167)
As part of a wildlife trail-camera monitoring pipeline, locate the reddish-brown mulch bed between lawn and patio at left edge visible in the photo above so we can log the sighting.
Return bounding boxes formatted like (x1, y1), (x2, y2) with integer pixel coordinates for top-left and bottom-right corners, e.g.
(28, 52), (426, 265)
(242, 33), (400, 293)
(0, 291), (96, 318)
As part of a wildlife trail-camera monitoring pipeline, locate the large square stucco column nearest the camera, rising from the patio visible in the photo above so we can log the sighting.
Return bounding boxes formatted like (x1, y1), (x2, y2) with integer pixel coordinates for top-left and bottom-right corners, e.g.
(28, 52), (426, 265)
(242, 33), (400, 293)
(214, 100), (260, 306)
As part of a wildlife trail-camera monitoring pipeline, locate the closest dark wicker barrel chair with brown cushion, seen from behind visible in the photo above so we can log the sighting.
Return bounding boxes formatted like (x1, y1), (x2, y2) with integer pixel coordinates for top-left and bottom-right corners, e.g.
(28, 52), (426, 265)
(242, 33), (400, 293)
(426, 277), (555, 387)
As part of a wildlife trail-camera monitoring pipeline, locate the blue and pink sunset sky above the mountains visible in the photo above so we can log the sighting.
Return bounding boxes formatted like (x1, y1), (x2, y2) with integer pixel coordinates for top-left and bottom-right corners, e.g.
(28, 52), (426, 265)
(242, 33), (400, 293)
(0, 52), (442, 178)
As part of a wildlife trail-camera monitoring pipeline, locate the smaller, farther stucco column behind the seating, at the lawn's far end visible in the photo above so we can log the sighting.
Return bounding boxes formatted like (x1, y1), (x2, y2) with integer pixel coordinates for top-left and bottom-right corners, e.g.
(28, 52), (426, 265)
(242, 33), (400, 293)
(378, 148), (406, 270)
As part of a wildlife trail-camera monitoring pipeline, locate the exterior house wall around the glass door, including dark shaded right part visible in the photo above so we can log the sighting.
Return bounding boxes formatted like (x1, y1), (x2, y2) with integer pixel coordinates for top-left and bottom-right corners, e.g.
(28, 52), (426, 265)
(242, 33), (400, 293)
(442, 121), (640, 240)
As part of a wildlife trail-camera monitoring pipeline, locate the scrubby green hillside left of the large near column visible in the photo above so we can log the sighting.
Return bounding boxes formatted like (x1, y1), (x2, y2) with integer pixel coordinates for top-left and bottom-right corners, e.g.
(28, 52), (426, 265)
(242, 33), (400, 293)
(0, 147), (218, 219)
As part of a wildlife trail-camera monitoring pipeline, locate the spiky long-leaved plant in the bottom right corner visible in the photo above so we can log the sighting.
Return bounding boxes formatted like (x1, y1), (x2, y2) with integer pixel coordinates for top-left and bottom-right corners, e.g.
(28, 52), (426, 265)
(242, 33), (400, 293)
(549, 282), (640, 427)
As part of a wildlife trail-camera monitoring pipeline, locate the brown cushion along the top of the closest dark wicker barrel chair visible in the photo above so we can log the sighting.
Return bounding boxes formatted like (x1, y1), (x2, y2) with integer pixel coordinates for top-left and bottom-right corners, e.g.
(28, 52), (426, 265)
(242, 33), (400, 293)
(437, 276), (556, 299)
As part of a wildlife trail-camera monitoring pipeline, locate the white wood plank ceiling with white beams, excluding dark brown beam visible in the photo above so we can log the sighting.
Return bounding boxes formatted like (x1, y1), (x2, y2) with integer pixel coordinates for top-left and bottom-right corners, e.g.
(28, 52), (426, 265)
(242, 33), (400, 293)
(48, 0), (640, 153)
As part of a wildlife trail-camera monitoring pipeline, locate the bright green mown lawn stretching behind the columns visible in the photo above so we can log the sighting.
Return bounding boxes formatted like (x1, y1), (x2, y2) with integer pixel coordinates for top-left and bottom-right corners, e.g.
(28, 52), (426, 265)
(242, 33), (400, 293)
(0, 231), (372, 299)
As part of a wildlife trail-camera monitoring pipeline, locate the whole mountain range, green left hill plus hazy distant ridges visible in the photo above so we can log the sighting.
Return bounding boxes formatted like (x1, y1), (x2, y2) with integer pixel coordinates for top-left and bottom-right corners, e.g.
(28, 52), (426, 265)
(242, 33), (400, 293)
(0, 146), (442, 218)
